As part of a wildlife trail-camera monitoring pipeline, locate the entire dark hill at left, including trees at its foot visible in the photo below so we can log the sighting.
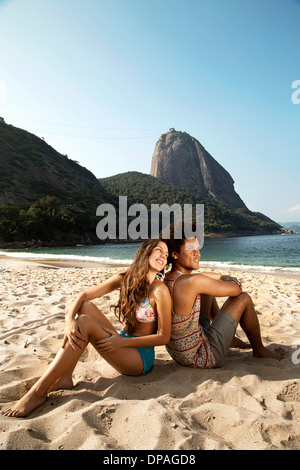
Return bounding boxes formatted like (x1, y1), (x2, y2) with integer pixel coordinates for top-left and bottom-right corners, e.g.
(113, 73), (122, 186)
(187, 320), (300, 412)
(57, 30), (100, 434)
(0, 119), (115, 248)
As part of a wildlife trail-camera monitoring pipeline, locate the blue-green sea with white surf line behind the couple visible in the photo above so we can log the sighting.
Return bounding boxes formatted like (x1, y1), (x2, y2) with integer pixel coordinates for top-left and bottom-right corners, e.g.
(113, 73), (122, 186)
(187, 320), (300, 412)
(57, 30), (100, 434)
(0, 234), (300, 274)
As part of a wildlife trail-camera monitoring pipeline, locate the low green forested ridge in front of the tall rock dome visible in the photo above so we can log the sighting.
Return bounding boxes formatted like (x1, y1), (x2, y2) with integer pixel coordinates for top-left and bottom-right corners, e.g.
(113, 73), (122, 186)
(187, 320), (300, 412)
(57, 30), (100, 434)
(99, 171), (281, 236)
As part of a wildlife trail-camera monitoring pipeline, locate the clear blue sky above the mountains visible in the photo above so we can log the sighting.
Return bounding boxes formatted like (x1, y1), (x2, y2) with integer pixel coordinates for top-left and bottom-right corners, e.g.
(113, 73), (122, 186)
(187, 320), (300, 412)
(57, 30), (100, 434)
(0, 0), (300, 222)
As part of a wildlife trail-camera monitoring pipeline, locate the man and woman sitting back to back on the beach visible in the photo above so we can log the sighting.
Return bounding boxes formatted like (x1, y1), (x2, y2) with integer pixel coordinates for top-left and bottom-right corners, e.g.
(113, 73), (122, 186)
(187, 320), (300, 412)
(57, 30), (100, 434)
(3, 227), (284, 417)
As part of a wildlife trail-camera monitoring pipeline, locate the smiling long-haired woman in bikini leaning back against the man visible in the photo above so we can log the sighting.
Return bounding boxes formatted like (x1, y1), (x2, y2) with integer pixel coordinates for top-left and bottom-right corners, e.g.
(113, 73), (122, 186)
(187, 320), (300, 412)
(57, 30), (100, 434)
(4, 240), (171, 418)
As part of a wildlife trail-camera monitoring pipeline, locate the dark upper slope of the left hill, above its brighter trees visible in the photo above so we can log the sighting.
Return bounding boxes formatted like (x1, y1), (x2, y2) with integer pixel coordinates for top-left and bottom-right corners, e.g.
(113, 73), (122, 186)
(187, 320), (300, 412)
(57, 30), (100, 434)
(0, 121), (110, 213)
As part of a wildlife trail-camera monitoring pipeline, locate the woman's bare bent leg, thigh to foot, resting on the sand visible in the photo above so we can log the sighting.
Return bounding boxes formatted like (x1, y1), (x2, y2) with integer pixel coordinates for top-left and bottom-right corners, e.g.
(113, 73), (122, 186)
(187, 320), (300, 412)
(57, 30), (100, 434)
(3, 304), (144, 418)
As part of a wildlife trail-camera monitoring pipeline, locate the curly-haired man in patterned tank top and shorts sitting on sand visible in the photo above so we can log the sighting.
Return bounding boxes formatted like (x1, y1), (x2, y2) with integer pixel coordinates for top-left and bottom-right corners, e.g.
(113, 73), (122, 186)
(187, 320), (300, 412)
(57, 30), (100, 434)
(162, 225), (284, 368)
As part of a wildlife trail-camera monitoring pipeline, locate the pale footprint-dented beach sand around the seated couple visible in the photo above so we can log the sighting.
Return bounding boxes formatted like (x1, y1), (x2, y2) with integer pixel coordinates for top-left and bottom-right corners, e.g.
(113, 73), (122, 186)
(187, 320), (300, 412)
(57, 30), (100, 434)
(0, 258), (300, 451)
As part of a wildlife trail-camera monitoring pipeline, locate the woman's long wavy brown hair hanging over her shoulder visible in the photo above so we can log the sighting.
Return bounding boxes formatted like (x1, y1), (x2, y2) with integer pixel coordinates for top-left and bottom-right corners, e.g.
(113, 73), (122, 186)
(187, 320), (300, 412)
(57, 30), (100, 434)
(115, 239), (161, 334)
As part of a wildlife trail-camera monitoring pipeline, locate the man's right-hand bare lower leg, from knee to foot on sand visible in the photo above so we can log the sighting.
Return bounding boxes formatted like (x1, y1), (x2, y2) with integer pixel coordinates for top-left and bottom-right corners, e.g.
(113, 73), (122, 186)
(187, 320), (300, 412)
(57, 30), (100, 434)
(222, 292), (285, 361)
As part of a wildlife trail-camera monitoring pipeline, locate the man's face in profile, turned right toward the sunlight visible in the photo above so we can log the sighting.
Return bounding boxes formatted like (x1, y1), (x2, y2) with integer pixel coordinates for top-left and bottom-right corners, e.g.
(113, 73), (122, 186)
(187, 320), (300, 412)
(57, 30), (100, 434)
(172, 238), (201, 274)
